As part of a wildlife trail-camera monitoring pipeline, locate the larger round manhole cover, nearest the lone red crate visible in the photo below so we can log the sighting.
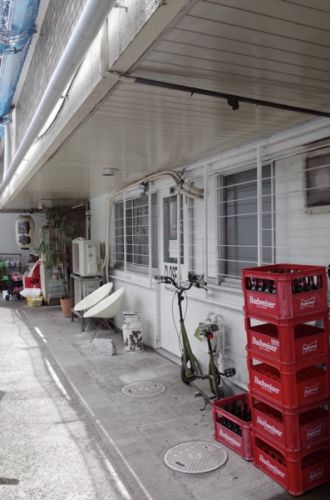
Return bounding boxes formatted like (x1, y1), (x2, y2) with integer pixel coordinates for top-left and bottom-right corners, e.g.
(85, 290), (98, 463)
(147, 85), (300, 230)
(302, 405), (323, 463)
(164, 441), (227, 474)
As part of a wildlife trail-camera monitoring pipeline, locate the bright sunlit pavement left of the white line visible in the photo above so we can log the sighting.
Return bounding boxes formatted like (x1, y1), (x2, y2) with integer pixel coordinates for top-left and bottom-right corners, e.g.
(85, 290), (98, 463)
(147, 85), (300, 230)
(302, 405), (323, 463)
(0, 302), (122, 500)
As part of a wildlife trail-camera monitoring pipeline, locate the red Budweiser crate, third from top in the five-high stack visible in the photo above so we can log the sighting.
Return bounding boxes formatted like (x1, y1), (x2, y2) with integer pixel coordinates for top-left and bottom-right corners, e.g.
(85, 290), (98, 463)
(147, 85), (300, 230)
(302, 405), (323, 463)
(248, 356), (329, 409)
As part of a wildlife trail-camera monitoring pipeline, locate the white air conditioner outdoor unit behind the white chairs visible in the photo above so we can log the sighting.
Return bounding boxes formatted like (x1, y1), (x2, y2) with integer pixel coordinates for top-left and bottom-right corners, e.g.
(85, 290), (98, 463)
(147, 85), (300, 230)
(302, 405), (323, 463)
(72, 238), (100, 276)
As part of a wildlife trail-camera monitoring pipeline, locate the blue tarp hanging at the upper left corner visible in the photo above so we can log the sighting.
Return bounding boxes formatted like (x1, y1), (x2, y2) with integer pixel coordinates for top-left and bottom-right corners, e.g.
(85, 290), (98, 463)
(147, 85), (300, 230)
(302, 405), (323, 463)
(0, 0), (40, 137)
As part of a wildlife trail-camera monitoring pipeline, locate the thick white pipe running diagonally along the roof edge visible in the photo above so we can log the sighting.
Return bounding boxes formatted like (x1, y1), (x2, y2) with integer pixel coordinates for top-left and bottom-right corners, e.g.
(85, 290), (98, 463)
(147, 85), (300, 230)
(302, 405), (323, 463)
(0, 0), (116, 195)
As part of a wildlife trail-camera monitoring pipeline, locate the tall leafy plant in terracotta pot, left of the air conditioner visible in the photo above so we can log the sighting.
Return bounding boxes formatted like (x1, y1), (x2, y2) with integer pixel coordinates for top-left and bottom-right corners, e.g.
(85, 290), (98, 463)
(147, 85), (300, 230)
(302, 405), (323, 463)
(37, 207), (75, 317)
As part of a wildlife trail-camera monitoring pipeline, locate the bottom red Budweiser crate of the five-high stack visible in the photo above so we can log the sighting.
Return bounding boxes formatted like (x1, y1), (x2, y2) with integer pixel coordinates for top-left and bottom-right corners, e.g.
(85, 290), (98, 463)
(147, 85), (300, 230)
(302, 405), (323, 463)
(254, 438), (330, 496)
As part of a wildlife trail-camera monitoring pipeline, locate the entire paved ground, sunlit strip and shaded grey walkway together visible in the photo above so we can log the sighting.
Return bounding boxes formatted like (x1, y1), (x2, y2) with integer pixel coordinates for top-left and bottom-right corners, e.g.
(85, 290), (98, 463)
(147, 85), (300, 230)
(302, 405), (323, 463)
(0, 303), (330, 500)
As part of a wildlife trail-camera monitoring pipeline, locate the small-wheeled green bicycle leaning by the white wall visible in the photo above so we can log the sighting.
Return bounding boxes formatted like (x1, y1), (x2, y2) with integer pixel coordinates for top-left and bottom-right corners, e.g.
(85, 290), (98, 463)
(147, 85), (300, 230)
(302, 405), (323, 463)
(155, 273), (236, 400)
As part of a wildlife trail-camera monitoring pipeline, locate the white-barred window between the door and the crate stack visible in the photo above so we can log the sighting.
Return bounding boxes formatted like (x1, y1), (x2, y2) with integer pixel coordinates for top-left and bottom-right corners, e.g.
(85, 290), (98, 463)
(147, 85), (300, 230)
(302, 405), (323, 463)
(217, 165), (274, 283)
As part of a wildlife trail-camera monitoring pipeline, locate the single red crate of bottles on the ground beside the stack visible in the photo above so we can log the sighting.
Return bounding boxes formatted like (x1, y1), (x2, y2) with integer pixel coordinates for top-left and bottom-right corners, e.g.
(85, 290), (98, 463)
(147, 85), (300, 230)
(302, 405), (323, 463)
(212, 393), (253, 460)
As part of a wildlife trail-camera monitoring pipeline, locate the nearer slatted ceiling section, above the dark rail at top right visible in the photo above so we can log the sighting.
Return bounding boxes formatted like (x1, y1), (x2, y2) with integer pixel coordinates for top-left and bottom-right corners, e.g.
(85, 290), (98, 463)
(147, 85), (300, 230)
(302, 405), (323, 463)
(134, 0), (330, 109)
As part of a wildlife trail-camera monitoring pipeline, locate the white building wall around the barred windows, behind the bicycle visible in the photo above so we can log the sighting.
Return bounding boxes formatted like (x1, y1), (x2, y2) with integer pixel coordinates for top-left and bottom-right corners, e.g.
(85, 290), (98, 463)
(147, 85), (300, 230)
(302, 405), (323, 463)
(91, 120), (330, 388)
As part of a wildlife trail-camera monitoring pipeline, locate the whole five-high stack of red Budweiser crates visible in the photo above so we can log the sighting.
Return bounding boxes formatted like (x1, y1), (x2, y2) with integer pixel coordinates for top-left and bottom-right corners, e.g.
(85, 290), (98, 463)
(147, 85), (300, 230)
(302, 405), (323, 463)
(242, 264), (330, 495)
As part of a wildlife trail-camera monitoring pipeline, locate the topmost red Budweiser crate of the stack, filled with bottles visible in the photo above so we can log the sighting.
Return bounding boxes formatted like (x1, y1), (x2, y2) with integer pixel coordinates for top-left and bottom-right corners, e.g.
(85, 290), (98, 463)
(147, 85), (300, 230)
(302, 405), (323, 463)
(242, 264), (328, 320)
